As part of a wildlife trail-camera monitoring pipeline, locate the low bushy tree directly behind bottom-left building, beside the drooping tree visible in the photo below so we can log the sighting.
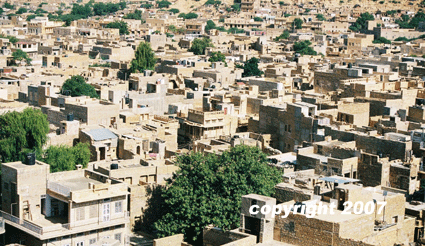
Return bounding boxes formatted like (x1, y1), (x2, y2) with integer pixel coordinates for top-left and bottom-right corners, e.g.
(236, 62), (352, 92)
(39, 143), (90, 173)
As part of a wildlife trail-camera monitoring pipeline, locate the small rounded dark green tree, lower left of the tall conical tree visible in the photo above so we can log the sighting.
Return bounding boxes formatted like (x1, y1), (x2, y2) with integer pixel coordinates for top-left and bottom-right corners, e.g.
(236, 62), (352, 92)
(61, 75), (99, 98)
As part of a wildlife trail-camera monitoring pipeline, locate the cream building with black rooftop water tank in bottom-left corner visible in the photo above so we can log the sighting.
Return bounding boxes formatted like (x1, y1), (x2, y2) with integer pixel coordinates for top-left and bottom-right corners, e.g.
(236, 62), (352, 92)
(1, 157), (129, 246)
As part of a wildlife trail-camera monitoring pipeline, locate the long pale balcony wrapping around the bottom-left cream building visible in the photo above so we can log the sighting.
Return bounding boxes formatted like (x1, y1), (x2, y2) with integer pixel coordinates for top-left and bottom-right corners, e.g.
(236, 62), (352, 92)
(0, 211), (130, 240)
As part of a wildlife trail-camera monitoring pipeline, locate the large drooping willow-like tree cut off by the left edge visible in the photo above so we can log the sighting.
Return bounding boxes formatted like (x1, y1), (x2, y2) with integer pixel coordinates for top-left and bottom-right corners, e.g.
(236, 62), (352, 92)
(0, 108), (49, 162)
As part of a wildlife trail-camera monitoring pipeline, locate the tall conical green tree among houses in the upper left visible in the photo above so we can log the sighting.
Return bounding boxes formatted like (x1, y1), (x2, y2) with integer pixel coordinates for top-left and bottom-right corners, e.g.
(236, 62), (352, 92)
(130, 42), (156, 73)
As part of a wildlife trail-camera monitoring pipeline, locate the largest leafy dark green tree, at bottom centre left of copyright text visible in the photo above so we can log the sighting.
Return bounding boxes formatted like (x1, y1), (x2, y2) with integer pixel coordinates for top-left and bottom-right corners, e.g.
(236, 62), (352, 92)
(154, 145), (281, 244)
